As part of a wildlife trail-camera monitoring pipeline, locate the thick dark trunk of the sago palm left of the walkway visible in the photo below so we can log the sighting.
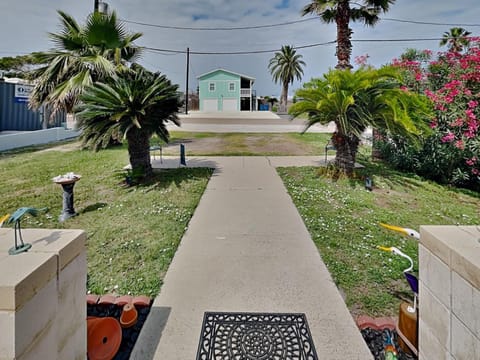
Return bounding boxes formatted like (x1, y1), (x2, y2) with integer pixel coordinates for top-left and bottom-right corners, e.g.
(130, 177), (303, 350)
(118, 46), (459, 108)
(127, 127), (153, 177)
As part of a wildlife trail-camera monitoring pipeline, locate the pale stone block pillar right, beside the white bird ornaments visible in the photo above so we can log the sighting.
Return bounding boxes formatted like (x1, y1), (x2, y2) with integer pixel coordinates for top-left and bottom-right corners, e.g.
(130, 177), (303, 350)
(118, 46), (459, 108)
(419, 226), (480, 360)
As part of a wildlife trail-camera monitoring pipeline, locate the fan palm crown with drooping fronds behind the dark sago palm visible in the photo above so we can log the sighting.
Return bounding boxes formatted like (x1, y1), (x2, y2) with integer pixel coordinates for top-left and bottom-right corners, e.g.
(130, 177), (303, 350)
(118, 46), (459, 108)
(30, 11), (142, 113)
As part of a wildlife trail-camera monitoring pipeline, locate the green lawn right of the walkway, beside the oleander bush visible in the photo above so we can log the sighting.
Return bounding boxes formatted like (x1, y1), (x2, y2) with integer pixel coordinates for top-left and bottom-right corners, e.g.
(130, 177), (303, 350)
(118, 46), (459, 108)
(278, 161), (480, 315)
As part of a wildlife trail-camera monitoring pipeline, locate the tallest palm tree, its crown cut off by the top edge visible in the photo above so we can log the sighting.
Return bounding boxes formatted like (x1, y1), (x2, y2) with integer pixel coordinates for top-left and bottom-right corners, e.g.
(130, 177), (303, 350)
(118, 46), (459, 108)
(301, 0), (395, 69)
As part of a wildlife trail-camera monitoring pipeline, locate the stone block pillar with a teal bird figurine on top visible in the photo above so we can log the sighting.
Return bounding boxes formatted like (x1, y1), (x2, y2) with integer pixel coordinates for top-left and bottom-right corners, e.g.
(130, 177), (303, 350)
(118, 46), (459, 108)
(0, 229), (87, 360)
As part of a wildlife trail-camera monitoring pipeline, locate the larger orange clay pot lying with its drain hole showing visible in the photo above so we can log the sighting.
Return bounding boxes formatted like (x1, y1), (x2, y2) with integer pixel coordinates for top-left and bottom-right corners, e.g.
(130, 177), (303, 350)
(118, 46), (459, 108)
(87, 316), (122, 360)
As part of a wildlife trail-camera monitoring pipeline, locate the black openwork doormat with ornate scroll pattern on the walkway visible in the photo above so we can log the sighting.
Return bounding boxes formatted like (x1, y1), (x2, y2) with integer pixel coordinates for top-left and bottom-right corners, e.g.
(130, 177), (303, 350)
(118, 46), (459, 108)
(197, 312), (318, 360)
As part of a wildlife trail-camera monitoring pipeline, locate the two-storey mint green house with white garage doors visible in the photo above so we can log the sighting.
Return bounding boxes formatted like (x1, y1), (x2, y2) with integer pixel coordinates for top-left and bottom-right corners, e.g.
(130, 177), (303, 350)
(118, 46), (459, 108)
(197, 69), (257, 112)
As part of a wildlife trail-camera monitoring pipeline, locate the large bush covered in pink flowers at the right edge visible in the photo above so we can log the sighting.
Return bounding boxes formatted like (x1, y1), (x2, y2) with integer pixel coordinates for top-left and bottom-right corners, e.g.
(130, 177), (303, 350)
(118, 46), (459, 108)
(381, 38), (480, 190)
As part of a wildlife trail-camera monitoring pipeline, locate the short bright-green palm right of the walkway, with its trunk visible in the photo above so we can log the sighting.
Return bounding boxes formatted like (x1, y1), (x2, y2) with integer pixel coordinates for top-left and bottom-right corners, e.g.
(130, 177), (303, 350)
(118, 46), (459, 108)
(290, 67), (430, 175)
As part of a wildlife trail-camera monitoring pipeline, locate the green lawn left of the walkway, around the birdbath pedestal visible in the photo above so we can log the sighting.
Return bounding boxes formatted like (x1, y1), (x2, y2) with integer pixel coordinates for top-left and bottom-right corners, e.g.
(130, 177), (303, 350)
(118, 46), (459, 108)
(0, 143), (211, 296)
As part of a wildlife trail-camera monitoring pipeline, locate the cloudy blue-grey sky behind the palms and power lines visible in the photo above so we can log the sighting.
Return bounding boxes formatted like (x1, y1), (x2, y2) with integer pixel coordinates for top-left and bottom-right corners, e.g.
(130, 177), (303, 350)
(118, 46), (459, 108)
(0, 0), (480, 96)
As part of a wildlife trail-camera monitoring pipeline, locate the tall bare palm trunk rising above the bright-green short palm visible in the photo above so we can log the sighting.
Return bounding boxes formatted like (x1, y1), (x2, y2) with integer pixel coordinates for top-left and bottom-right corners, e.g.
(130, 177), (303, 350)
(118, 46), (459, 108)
(335, 0), (352, 70)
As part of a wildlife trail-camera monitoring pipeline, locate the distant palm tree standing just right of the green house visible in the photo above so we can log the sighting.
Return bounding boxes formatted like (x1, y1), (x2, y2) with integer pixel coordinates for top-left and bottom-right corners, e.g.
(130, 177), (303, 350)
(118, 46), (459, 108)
(268, 45), (305, 111)
